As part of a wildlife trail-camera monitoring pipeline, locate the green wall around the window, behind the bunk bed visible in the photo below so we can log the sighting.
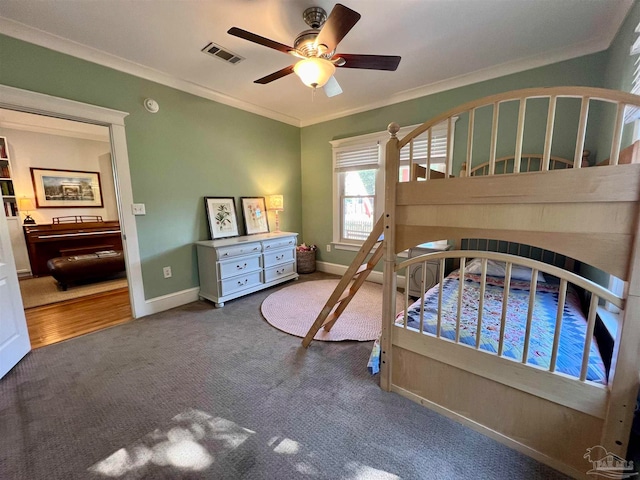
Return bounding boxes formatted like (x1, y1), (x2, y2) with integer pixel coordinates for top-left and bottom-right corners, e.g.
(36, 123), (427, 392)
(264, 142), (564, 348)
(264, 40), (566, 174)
(301, 52), (608, 265)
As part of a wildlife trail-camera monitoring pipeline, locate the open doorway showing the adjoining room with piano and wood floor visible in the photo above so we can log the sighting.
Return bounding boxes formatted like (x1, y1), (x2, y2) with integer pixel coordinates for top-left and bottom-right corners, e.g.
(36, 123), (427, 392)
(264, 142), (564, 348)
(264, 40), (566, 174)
(0, 109), (133, 348)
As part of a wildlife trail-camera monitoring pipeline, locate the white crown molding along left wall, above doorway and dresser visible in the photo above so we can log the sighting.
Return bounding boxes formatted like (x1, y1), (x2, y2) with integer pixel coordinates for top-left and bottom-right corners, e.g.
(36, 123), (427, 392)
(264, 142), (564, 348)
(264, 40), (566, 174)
(0, 17), (300, 127)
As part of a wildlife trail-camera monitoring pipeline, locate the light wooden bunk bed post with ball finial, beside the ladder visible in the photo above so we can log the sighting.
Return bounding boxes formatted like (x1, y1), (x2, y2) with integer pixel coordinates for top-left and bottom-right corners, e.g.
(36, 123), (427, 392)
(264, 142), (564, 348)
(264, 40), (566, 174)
(380, 123), (400, 392)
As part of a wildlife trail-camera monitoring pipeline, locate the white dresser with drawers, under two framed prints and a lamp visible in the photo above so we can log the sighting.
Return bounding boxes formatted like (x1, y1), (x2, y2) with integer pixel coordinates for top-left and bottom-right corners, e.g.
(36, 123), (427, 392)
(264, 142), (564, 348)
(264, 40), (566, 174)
(196, 232), (298, 307)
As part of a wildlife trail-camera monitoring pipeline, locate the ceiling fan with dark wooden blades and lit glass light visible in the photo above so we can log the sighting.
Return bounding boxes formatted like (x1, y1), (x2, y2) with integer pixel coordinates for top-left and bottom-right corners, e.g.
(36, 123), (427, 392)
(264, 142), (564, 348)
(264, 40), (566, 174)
(227, 3), (400, 97)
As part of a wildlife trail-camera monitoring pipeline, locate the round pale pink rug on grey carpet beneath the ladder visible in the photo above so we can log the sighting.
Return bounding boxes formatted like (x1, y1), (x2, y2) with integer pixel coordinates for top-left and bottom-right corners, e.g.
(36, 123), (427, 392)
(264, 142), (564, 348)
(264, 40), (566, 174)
(261, 280), (403, 342)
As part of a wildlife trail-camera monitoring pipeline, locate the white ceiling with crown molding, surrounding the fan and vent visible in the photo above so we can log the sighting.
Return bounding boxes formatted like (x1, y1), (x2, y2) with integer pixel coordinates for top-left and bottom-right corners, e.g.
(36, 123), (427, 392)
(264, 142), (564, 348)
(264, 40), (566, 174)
(0, 0), (633, 126)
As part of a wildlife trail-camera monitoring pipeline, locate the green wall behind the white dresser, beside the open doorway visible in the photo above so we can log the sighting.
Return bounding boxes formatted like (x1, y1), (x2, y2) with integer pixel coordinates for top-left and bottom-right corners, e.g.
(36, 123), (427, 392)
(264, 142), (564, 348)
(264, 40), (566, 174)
(0, 35), (302, 299)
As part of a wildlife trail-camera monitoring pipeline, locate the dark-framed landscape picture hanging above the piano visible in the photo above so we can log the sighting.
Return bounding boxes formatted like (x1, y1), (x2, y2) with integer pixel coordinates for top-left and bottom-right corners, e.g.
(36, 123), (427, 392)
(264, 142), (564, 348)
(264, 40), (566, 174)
(31, 168), (103, 208)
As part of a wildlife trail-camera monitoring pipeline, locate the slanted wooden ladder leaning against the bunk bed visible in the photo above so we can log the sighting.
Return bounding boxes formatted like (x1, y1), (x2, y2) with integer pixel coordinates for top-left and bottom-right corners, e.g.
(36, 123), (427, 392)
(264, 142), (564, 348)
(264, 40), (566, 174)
(302, 215), (384, 348)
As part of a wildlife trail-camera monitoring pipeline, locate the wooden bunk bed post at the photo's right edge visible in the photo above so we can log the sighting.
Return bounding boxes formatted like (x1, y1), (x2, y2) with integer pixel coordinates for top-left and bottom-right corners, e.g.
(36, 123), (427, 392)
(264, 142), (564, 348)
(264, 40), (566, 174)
(601, 205), (640, 458)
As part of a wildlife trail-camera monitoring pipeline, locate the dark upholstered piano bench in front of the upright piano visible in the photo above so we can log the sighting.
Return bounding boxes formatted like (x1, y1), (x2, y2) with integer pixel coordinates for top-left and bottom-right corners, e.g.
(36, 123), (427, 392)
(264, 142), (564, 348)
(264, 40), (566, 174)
(47, 250), (125, 290)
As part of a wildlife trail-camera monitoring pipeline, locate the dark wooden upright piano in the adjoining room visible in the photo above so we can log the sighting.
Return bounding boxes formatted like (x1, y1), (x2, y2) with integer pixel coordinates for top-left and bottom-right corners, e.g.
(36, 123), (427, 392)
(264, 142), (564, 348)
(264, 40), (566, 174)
(24, 217), (122, 276)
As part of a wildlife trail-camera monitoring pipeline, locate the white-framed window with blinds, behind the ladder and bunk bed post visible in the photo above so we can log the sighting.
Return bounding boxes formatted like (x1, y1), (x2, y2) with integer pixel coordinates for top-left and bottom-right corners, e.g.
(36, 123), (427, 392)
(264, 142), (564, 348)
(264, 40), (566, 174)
(330, 123), (453, 249)
